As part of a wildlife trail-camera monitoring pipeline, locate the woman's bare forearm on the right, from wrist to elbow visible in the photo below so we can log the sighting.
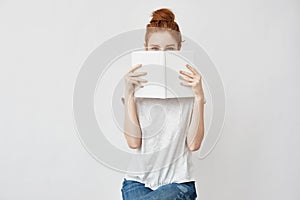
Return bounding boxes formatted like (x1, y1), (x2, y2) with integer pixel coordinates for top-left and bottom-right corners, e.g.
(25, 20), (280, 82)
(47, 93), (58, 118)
(186, 97), (204, 151)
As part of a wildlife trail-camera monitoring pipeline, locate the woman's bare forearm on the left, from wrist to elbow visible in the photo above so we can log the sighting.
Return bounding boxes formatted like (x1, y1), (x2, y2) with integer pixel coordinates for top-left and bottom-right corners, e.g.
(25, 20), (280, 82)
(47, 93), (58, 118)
(124, 94), (142, 148)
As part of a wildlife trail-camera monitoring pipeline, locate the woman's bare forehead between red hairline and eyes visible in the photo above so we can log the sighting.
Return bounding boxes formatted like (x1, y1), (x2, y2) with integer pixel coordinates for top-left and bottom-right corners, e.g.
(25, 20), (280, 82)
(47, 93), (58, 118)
(148, 31), (177, 46)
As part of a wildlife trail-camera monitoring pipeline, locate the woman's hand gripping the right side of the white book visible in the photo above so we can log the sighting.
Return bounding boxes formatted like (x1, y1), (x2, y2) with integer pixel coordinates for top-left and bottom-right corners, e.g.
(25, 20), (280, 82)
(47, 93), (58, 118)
(179, 64), (204, 99)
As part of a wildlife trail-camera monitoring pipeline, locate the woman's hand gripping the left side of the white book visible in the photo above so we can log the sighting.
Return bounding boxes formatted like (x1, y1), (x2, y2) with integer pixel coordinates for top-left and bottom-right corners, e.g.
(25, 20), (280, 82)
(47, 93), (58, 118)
(125, 64), (148, 95)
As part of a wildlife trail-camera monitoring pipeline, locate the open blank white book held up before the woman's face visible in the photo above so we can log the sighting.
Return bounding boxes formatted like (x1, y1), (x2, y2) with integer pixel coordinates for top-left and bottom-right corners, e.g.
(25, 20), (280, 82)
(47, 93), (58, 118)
(131, 51), (194, 99)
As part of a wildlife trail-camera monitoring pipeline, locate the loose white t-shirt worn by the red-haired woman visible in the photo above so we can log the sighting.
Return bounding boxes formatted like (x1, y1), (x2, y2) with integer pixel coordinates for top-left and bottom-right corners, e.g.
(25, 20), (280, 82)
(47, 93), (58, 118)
(125, 97), (195, 190)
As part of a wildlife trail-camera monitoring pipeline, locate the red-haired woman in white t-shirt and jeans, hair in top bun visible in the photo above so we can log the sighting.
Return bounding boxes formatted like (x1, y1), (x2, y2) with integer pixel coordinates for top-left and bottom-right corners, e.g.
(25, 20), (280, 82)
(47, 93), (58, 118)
(121, 8), (205, 200)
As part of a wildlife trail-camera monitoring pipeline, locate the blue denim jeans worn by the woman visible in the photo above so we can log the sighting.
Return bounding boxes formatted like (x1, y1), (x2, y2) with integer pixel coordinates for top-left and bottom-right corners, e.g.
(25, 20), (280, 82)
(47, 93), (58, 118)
(121, 178), (197, 200)
